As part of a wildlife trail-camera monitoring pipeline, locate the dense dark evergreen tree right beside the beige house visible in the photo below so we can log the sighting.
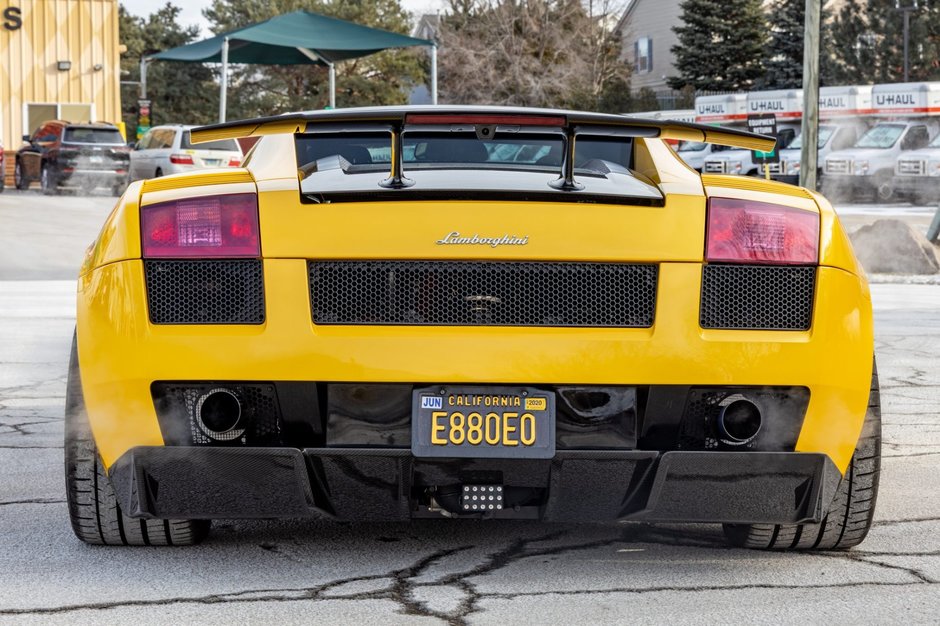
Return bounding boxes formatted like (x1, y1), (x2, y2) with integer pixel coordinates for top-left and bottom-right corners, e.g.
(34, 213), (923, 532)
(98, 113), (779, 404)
(668, 0), (769, 91)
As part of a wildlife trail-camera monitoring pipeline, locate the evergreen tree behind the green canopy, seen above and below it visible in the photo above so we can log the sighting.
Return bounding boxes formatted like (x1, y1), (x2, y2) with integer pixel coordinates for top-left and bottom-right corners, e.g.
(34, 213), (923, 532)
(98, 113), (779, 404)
(203, 0), (427, 119)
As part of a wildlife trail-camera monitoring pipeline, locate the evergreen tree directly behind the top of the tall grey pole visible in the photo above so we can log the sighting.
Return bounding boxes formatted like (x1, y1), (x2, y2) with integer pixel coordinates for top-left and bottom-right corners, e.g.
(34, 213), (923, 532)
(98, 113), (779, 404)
(760, 0), (833, 89)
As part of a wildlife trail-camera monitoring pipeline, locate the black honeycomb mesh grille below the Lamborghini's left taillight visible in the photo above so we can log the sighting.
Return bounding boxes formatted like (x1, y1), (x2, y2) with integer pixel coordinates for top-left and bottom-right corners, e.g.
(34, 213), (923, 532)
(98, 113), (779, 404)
(144, 259), (264, 324)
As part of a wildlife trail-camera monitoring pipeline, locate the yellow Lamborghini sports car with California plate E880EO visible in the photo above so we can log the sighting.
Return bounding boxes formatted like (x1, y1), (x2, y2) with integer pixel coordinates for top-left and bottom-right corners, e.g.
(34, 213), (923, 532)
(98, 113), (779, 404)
(65, 106), (881, 549)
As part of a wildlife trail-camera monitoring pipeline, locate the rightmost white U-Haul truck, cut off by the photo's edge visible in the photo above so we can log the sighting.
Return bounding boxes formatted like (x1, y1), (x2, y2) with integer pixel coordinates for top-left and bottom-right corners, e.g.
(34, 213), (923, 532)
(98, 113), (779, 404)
(822, 82), (940, 200)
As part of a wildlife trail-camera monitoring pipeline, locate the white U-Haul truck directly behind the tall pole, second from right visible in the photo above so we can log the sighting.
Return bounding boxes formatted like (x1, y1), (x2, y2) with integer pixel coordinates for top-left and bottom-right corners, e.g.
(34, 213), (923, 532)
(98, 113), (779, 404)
(771, 85), (872, 185)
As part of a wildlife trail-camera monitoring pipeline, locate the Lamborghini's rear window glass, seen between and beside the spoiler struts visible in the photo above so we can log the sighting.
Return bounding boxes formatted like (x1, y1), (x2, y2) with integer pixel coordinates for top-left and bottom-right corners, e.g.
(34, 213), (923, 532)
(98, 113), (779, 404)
(297, 131), (633, 170)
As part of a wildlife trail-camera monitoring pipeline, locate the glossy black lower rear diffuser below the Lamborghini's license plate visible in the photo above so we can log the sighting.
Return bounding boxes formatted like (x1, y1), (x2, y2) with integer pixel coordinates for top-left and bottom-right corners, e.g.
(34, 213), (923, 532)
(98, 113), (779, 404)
(110, 446), (841, 523)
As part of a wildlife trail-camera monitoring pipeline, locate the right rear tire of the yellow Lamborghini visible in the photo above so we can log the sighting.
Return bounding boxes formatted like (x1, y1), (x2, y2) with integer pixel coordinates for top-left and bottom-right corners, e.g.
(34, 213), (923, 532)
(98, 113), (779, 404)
(724, 369), (881, 550)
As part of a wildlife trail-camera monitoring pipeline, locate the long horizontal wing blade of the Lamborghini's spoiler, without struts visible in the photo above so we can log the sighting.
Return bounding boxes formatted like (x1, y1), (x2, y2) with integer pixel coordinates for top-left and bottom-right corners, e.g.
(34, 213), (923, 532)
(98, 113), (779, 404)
(190, 106), (776, 152)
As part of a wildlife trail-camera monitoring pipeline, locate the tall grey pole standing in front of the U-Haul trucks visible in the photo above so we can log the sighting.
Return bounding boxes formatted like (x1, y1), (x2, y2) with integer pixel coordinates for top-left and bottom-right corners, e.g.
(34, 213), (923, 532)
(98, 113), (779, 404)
(800, 0), (822, 191)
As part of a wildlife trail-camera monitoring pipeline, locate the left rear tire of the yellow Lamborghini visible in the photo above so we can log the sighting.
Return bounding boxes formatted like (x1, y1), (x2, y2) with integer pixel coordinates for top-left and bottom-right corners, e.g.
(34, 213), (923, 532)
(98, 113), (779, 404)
(65, 335), (210, 546)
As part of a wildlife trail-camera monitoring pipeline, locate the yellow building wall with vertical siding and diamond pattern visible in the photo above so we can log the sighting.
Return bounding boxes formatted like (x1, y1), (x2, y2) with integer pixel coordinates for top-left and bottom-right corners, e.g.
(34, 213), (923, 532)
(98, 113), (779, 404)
(0, 0), (121, 173)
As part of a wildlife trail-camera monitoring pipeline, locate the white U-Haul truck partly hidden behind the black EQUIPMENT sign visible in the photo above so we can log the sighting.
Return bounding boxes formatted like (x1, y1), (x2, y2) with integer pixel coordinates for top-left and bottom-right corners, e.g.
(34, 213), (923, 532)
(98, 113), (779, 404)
(702, 89), (803, 176)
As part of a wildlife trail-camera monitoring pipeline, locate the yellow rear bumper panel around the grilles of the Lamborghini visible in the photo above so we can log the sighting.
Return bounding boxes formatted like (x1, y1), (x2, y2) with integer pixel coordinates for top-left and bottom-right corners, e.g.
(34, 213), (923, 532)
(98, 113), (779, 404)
(78, 258), (872, 471)
